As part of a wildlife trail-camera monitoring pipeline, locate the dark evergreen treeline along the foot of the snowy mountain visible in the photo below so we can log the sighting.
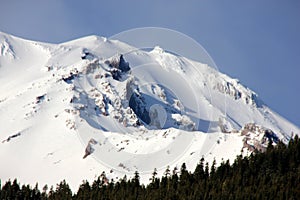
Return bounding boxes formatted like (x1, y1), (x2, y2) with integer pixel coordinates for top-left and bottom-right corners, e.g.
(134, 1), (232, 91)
(0, 136), (300, 200)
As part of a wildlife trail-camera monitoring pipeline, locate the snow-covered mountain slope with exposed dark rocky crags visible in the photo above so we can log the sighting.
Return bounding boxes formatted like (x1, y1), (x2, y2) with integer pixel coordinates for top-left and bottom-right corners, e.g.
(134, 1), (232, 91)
(0, 32), (299, 190)
